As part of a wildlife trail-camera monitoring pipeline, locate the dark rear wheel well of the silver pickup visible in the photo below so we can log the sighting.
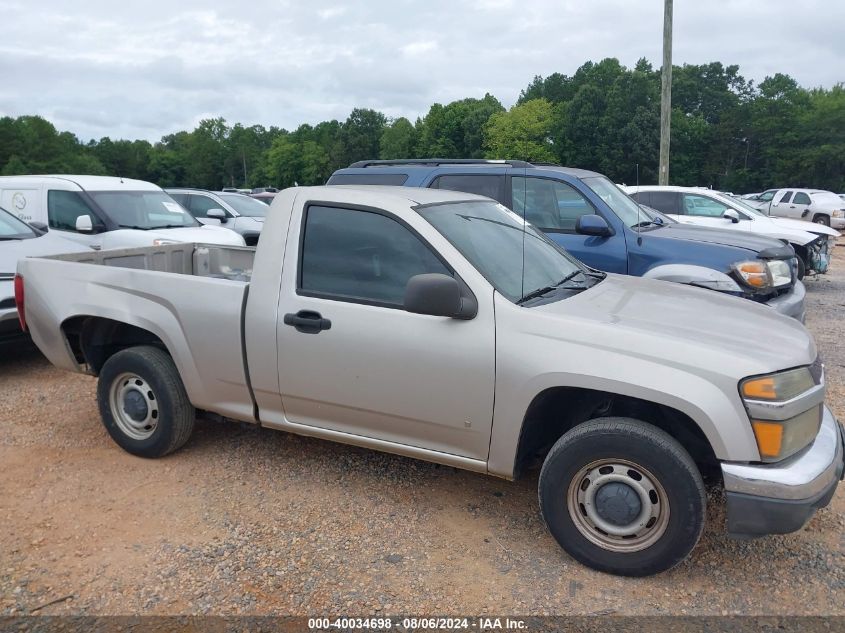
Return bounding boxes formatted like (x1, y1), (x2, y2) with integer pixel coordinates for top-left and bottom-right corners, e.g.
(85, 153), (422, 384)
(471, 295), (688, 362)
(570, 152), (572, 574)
(62, 316), (167, 375)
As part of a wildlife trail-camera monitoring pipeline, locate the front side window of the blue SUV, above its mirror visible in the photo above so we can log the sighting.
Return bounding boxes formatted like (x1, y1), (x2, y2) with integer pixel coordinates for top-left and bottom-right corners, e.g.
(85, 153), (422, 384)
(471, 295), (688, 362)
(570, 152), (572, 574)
(511, 176), (596, 231)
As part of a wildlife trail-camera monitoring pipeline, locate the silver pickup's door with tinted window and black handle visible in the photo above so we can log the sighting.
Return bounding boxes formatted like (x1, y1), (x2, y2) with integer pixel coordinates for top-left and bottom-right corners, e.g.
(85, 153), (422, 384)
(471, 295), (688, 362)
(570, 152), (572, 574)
(276, 205), (495, 460)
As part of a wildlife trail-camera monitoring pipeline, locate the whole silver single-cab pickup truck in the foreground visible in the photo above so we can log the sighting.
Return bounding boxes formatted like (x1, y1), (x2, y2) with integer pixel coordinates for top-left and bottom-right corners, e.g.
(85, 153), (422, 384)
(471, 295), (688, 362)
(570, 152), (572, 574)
(16, 187), (843, 576)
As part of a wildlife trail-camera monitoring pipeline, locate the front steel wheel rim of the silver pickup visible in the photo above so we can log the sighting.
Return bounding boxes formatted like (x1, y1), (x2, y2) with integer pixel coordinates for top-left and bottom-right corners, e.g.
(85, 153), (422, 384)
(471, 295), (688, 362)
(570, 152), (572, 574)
(566, 459), (669, 553)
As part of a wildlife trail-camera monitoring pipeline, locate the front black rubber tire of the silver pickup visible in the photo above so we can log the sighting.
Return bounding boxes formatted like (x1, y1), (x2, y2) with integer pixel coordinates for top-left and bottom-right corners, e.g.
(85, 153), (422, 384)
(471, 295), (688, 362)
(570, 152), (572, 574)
(539, 418), (706, 576)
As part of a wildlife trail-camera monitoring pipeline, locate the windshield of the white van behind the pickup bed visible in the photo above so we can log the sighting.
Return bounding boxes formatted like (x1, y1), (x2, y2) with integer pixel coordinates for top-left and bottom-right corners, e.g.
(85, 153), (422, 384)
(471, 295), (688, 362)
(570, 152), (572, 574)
(89, 191), (199, 231)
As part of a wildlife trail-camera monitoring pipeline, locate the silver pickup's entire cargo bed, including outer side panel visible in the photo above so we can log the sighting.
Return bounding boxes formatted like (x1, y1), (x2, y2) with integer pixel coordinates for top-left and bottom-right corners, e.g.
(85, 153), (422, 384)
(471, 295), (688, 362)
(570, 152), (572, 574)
(18, 243), (255, 420)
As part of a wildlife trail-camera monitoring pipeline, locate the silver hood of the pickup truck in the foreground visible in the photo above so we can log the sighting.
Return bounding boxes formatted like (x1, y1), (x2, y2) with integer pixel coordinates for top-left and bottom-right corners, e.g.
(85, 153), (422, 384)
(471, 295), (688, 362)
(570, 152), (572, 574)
(526, 274), (816, 378)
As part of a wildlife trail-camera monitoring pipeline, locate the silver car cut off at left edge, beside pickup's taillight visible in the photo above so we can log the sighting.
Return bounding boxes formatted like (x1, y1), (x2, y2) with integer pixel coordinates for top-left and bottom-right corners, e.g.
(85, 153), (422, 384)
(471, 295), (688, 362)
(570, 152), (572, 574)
(0, 208), (91, 343)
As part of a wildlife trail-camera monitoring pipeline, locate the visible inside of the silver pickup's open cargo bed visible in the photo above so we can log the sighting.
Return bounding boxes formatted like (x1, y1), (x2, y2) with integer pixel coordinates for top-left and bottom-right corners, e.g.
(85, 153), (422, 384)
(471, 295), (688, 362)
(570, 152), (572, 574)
(45, 243), (255, 281)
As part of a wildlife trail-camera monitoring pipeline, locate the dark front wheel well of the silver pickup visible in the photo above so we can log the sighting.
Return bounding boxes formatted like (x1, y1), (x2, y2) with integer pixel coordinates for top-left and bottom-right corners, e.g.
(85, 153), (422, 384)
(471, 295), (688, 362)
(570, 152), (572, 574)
(514, 387), (721, 479)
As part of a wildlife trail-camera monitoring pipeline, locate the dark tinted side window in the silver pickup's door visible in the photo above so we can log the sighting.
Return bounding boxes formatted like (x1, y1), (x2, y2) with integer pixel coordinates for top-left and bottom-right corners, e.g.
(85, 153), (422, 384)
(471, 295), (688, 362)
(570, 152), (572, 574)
(298, 206), (452, 307)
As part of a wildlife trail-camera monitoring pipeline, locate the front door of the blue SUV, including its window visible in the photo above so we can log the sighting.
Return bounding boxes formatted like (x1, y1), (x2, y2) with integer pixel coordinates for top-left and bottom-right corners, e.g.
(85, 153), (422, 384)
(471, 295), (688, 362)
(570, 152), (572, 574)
(508, 176), (628, 274)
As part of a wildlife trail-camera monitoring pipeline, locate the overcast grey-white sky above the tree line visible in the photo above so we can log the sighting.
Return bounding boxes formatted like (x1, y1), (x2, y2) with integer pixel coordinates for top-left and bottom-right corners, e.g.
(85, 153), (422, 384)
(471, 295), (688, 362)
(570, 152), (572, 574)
(0, 0), (845, 141)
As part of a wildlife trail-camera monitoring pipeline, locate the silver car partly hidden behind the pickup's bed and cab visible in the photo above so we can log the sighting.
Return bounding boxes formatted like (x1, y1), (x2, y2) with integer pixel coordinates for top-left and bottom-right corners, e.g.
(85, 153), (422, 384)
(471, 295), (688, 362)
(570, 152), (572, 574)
(165, 189), (267, 246)
